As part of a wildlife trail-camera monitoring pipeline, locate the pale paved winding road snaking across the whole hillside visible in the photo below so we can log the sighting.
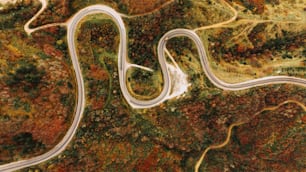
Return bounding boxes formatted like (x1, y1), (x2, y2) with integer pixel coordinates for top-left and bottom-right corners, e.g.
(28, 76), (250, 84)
(0, 0), (306, 171)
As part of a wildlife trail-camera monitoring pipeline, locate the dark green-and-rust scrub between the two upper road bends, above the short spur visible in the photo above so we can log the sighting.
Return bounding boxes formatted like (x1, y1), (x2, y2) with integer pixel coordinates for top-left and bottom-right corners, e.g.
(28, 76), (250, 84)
(128, 0), (202, 70)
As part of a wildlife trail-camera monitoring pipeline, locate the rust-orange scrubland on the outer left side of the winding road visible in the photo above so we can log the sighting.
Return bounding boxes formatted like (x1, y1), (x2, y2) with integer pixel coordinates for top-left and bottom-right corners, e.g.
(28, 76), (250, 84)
(0, 0), (75, 165)
